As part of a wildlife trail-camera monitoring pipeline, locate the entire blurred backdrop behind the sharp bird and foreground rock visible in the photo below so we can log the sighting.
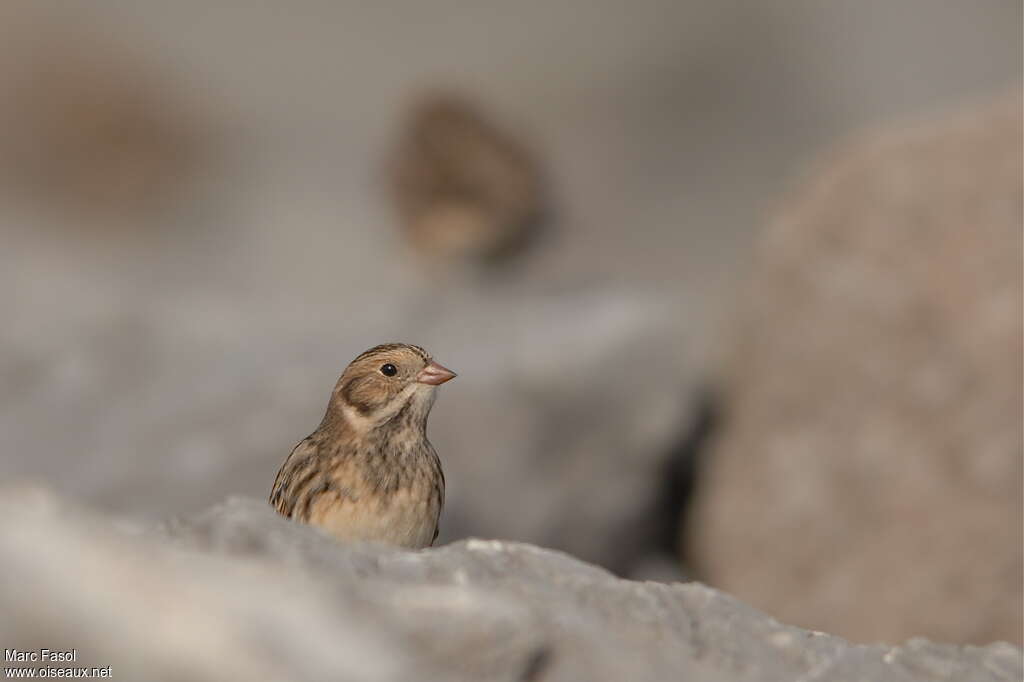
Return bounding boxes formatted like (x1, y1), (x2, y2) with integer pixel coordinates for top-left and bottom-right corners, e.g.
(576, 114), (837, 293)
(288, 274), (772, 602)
(0, 0), (1022, 644)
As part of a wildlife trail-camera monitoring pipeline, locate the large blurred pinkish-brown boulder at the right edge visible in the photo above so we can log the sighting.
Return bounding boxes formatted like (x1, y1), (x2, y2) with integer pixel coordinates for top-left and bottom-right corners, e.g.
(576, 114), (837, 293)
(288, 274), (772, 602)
(689, 94), (1022, 643)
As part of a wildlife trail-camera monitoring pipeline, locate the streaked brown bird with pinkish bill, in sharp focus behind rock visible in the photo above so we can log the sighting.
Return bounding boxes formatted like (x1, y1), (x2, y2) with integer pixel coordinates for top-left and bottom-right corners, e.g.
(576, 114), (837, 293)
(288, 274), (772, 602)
(270, 343), (456, 549)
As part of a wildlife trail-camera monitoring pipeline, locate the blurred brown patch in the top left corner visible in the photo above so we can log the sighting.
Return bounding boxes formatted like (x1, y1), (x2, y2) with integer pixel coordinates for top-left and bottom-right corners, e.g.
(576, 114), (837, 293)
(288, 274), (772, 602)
(0, 15), (205, 224)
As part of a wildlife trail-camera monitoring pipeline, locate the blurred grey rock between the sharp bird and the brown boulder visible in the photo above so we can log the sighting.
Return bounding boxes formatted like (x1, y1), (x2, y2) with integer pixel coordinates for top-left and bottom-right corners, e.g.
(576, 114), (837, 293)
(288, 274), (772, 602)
(426, 280), (699, 574)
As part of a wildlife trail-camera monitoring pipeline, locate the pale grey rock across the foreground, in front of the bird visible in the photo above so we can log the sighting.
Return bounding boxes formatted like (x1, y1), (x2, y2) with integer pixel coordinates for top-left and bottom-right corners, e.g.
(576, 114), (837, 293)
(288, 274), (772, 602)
(0, 487), (1022, 682)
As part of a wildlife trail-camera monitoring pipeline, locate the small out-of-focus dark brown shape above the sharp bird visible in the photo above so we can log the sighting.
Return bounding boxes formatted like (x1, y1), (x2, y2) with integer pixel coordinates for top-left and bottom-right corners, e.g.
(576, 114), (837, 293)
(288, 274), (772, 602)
(392, 93), (545, 264)
